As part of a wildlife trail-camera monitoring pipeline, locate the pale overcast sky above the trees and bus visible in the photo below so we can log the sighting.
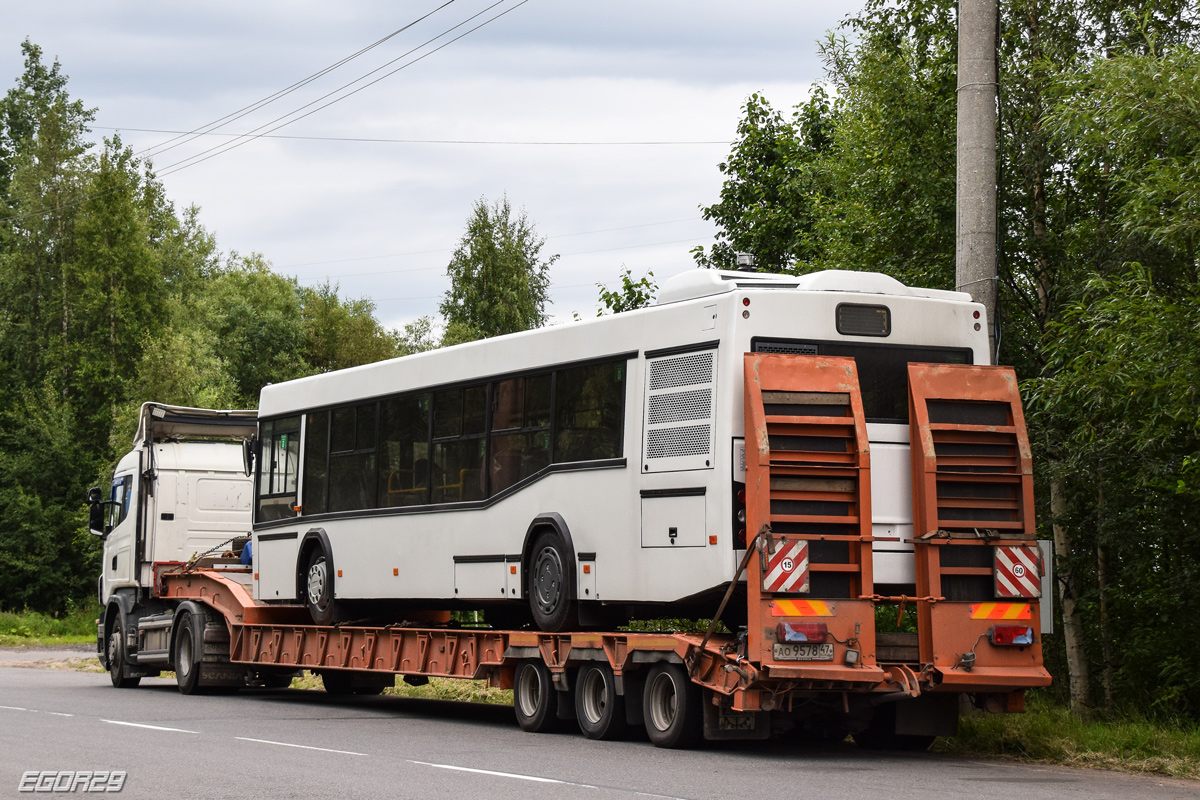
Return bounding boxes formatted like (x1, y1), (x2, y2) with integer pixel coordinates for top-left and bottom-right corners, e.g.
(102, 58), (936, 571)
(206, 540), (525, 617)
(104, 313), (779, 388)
(0, 0), (862, 326)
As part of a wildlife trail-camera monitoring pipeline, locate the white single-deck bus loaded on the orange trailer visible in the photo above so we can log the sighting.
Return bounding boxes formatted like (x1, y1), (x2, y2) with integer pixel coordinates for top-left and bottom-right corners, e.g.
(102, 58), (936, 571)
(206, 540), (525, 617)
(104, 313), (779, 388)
(253, 270), (988, 631)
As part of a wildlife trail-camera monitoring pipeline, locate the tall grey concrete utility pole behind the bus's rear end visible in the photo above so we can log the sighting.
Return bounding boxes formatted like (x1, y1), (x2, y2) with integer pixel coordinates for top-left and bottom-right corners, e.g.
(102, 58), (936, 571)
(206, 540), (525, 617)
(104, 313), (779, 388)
(954, 0), (997, 359)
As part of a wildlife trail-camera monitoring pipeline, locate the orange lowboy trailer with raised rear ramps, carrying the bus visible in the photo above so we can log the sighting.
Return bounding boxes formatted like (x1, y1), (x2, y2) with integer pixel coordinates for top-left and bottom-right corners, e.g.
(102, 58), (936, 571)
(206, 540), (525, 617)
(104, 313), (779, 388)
(97, 353), (1050, 748)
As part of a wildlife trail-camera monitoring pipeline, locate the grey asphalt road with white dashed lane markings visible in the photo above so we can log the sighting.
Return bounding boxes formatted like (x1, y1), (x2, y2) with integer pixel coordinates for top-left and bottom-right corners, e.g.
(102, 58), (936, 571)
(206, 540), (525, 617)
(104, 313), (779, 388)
(0, 668), (1200, 800)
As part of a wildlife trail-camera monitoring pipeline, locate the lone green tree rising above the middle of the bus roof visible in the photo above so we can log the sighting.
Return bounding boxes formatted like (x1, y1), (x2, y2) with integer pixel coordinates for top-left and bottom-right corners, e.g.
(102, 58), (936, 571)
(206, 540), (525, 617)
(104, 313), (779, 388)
(440, 197), (558, 344)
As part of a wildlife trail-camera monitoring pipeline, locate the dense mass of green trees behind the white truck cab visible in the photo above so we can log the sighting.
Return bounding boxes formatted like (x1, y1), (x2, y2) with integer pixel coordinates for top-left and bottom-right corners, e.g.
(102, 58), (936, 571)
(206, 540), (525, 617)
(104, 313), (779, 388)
(0, 41), (400, 613)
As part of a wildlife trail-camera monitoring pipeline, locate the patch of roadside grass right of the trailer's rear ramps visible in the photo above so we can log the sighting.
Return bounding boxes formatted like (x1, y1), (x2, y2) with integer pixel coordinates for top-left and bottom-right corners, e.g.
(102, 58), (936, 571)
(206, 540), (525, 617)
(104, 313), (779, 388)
(934, 694), (1200, 778)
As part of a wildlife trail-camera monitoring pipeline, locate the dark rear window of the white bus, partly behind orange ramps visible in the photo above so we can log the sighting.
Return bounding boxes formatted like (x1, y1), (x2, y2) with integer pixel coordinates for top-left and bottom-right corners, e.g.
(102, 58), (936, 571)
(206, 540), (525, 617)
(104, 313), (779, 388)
(752, 339), (972, 425)
